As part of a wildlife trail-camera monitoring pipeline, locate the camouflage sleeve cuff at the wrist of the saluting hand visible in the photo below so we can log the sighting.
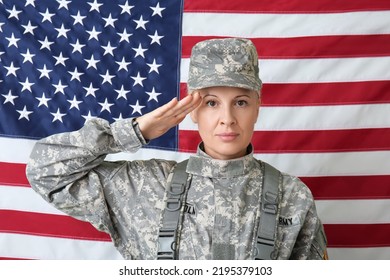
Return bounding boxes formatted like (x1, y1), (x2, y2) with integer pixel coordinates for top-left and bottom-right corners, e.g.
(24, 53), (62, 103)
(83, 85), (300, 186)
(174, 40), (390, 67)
(111, 118), (148, 153)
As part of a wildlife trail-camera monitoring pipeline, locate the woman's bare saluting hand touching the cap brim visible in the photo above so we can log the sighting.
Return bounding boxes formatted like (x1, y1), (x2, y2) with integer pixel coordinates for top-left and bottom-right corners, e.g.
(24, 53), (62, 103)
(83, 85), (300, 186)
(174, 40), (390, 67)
(137, 92), (202, 140)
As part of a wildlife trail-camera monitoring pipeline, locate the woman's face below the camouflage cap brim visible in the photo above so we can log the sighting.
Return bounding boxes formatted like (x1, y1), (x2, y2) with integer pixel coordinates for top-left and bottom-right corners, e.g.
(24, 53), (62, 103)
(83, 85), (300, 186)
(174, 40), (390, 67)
(191, 87), (259, 160)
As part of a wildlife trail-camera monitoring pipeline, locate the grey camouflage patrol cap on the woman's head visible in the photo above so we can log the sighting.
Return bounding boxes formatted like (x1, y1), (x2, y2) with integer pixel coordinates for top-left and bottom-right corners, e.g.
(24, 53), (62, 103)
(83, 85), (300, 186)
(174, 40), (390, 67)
(187, 38), (262, 91)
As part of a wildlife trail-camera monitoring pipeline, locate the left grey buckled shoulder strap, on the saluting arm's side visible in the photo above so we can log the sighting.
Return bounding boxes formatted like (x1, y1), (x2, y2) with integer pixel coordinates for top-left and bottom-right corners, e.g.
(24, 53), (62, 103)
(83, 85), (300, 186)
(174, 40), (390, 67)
(157, 160), (188, 260)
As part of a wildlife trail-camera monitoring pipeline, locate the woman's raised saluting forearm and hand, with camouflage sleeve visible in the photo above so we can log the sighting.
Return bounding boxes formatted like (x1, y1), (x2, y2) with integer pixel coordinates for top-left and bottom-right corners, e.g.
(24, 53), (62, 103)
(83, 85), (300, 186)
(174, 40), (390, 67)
(27, 94), (200, 200)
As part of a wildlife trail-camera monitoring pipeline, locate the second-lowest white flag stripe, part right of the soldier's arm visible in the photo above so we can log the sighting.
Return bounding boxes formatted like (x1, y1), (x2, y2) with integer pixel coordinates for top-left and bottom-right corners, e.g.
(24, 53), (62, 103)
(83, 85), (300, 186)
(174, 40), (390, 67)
(316, 199), (390, 224)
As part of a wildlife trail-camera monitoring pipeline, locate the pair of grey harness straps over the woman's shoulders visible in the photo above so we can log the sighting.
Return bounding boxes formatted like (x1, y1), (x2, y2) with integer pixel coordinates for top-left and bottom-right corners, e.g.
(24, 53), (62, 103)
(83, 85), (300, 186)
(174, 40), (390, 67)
(157, 160), (282, 260)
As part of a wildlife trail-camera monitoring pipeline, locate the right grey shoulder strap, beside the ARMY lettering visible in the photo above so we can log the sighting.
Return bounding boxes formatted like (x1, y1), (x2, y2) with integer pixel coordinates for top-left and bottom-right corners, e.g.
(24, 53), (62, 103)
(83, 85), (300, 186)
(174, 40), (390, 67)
(254, 162), (281, 260)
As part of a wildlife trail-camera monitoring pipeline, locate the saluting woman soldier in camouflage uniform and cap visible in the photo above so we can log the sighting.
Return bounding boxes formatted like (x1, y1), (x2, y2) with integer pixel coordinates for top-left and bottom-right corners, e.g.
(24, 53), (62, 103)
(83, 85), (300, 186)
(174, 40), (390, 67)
(27, 38), (326, 259)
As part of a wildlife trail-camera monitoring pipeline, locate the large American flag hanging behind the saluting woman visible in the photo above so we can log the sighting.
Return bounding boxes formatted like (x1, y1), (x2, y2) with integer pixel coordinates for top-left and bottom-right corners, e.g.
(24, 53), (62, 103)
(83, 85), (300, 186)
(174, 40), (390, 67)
(0, 0), (390, 259)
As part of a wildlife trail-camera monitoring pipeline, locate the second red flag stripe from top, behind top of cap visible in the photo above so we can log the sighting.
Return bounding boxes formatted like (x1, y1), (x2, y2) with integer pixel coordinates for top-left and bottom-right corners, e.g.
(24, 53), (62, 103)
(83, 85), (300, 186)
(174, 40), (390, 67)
(182, 34), (390, 59)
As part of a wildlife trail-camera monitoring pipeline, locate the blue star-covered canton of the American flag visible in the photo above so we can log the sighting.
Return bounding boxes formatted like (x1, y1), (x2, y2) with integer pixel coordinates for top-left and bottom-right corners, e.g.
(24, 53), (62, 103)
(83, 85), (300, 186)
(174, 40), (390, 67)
(0, 0), (182, 149)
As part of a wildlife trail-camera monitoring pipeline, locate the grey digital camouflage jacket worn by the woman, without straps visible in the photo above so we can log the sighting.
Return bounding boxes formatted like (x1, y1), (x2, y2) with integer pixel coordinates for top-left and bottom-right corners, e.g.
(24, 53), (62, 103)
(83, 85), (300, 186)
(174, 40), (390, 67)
(27, 116), (326, 259)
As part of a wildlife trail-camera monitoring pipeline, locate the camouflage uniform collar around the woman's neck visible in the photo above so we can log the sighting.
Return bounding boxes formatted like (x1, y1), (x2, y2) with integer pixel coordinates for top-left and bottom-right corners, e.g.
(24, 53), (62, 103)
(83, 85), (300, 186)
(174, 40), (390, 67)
(187, 143), (256, 178)
